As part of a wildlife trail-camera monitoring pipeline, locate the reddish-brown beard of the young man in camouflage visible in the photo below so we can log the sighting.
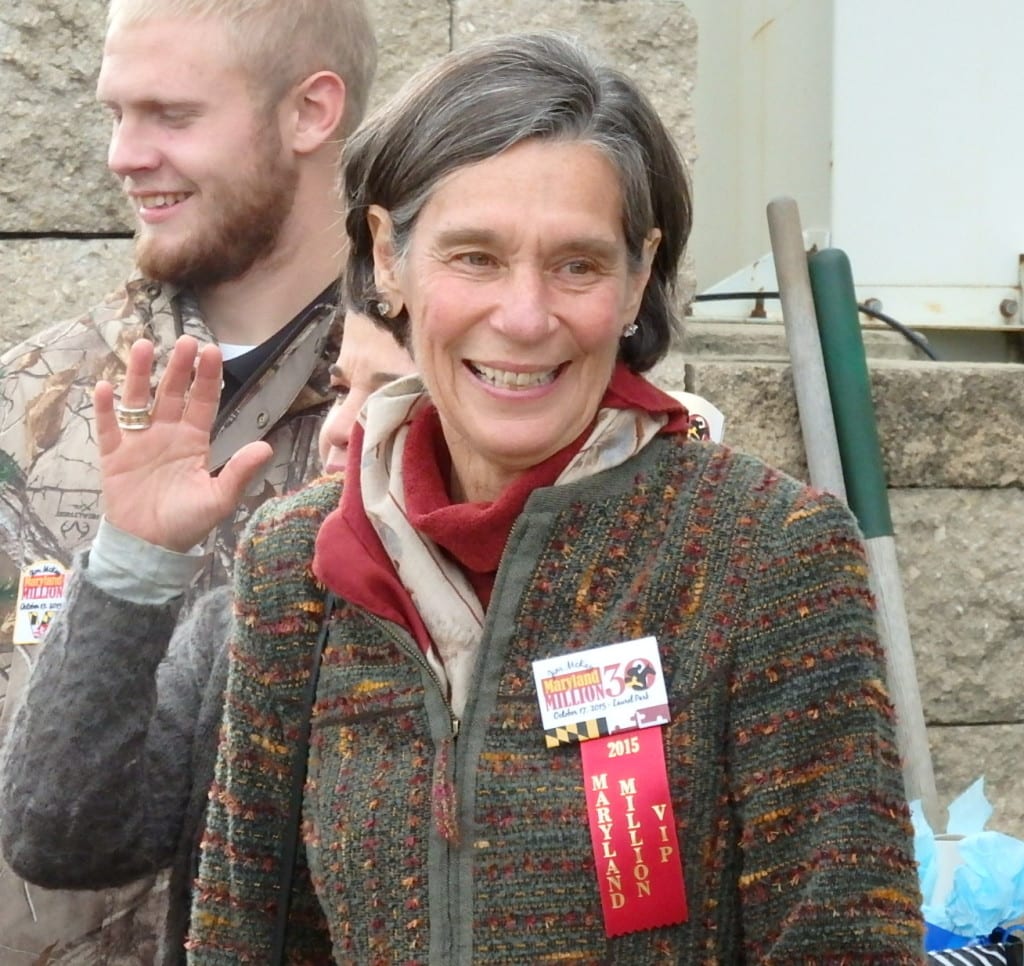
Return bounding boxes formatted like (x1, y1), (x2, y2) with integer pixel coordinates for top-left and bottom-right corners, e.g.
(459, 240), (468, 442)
(135, 131), (298, 290)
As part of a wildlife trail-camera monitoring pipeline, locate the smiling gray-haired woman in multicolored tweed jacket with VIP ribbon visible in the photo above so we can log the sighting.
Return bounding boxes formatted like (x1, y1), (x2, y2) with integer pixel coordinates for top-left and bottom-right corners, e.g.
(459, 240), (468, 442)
(189, 26), (922, 964)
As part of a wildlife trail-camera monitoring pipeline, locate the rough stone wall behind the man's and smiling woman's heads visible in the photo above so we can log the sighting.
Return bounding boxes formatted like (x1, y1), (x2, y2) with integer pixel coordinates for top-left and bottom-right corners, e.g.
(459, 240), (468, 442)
(0, 0), (696, 348)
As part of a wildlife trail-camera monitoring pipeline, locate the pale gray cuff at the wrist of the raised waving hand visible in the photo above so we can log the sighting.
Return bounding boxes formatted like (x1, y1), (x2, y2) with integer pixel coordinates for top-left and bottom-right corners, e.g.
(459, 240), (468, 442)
(86, 516), (203, 604)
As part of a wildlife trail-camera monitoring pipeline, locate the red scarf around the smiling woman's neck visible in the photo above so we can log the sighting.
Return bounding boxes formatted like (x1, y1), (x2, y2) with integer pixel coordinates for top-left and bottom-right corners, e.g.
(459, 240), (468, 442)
(313, 363), (689, 653)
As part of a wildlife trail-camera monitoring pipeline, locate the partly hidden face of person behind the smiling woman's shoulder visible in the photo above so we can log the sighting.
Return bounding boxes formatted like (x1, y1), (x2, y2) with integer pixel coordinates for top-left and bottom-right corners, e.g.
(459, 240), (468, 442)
(319, 312), (416, 473)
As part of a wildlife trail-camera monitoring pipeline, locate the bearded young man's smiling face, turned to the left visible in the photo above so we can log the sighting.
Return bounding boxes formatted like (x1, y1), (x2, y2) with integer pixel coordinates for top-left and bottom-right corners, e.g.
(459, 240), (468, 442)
(96, 17), (297, 288)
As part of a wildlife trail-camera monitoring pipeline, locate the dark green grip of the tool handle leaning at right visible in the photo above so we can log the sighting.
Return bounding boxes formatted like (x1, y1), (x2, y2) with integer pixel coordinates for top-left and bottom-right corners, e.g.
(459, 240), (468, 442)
(807, 248), (893, 540)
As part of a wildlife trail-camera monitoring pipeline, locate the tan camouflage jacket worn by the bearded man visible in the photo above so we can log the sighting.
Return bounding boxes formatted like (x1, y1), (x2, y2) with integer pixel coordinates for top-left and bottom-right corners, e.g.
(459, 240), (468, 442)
(0, 279), (340, 966)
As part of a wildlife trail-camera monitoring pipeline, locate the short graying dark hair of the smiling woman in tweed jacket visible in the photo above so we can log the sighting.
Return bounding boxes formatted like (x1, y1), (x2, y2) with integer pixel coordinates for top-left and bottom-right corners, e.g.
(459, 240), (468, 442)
(343, 32), (692, 372)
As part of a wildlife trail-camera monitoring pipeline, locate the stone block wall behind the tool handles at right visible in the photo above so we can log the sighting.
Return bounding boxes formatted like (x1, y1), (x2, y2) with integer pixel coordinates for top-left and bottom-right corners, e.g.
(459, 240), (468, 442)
(659, 356), (1024, 837)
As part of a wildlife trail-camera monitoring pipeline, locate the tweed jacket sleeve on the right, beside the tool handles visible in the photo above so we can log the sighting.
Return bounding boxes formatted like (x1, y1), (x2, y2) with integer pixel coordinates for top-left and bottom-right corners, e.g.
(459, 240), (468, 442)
(729, 476), (923, 966)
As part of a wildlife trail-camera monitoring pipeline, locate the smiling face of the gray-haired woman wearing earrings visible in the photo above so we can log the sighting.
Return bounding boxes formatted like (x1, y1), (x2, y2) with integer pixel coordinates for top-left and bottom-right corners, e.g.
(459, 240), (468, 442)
(370, 140), (657, 500)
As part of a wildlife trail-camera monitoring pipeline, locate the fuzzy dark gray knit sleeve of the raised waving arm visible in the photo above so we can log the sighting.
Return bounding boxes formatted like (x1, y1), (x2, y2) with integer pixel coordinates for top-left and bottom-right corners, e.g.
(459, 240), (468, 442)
(0, 572), (230, 889)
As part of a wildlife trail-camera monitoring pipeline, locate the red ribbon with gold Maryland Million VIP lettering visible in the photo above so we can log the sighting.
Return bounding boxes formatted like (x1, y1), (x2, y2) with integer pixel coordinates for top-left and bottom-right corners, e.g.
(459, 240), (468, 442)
(580, 727), (687, 936)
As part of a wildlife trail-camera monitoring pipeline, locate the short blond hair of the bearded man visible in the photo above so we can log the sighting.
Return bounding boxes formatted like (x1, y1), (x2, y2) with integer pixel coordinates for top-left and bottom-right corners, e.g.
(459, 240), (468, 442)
(106, 0), (377, 137)
